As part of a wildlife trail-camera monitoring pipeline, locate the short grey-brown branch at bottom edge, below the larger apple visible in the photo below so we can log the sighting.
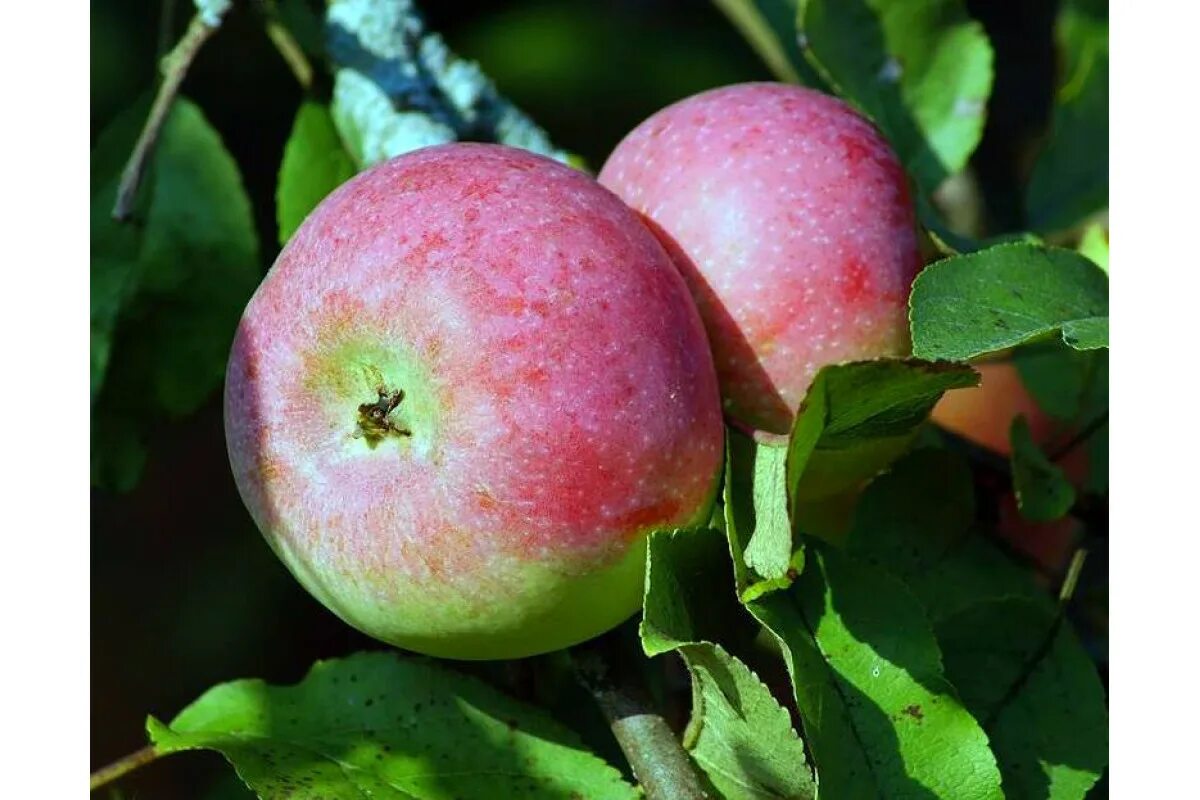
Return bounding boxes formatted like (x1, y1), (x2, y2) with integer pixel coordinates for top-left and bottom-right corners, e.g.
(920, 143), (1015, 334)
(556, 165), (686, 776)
(571, 644), (709, 800)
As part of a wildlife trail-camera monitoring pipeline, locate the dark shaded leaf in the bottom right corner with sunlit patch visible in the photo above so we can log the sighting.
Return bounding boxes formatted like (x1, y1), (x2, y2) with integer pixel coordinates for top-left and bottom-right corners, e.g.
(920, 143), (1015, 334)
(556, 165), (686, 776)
(937, 597), (1108, 800)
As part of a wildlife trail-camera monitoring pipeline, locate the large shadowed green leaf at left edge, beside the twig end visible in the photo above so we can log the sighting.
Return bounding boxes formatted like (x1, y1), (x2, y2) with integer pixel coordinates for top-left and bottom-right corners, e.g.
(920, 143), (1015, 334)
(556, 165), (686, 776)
(91, 98), (260, 488)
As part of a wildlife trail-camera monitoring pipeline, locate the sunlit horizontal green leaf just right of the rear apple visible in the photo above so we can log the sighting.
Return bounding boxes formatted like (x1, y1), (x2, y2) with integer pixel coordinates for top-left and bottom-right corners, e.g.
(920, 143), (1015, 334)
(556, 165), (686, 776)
(908, 245), (1109, 361)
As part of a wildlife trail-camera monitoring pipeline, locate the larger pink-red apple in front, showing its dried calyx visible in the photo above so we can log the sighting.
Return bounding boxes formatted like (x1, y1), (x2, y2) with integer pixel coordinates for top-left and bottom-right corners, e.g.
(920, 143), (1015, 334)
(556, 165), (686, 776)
(224, 144), (724, 658)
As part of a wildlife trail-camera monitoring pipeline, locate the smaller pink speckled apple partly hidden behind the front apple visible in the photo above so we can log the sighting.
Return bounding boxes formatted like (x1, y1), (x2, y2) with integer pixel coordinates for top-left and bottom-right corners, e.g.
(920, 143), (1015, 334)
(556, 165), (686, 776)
(600, 83), (920, 435)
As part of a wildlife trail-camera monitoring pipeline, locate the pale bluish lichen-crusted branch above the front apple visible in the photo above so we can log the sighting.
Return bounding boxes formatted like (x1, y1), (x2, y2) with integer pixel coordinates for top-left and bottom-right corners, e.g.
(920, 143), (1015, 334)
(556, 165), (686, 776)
(325, 0), (566, 168)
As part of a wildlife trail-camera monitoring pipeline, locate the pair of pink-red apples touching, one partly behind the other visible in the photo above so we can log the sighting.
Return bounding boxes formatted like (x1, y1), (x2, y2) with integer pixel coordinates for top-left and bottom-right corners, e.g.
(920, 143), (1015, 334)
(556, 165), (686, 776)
(226, 84), (920, 658)
